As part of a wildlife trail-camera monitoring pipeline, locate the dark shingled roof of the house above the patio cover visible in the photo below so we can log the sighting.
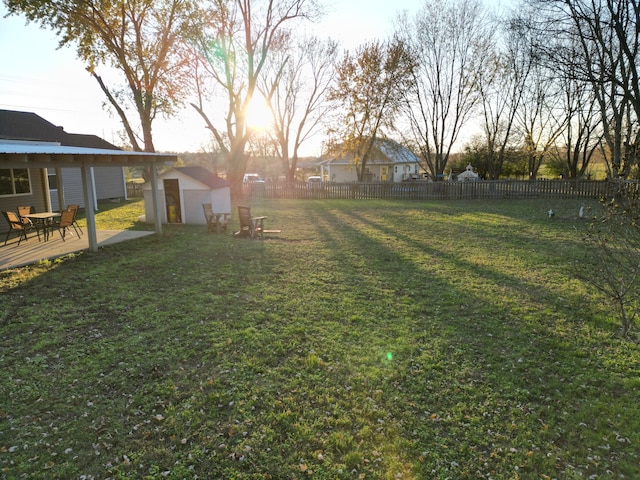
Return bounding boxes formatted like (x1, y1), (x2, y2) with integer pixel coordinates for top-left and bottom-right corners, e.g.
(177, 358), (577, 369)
(0, 110), (120, 150)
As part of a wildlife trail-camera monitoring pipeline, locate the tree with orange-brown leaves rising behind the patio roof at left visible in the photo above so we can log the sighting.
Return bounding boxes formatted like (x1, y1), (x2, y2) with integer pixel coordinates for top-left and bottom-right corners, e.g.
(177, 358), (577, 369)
(5, 0), (196, 152)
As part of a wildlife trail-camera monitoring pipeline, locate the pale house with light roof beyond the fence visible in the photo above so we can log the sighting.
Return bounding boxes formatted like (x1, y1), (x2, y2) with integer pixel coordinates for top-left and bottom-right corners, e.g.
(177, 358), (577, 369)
(320, 139), (423, 182)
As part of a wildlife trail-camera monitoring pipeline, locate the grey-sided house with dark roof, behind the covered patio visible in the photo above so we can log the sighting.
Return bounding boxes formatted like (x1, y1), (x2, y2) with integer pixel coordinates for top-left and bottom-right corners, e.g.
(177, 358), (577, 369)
(0, 110), (127, 210)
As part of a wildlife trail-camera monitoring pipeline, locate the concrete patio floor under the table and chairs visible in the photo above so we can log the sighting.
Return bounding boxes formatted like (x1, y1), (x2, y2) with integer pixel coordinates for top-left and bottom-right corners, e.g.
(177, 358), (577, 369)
(0, 230), (155, 270)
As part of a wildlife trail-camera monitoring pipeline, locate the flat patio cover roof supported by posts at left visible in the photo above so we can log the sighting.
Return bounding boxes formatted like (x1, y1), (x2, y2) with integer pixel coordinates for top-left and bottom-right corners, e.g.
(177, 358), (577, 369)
(0, 142), (177, 168)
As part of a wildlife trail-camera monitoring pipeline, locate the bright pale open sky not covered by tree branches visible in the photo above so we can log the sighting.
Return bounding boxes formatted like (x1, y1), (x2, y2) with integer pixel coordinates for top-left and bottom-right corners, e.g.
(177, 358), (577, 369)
(0, 0), (500, 155)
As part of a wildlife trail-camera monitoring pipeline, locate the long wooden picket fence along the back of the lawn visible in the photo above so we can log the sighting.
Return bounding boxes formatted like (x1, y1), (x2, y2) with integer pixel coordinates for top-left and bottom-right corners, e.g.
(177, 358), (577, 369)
(243, 180), (611, 200)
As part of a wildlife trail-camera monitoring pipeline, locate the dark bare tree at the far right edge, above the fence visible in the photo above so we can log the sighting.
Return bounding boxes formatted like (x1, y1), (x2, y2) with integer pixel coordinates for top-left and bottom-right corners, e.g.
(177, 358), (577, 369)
(530, 0), (640, 177)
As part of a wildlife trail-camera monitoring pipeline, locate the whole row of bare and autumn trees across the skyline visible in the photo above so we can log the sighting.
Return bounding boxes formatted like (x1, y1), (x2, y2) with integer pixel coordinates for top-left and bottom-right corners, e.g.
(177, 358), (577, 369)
(4, 0), (640, 193)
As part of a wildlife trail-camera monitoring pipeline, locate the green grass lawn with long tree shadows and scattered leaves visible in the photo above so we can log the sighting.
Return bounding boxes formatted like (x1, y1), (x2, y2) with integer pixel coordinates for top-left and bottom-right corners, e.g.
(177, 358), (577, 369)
(0, 200), (640, 480)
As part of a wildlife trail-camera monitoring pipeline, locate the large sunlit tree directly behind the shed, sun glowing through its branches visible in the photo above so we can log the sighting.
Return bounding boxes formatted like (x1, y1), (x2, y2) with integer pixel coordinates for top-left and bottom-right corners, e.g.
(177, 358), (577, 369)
(191, 0), (320, 196)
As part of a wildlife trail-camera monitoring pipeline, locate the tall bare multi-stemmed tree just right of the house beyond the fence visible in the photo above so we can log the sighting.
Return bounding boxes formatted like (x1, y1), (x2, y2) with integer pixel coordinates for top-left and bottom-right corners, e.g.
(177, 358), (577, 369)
(400, 0), (492, 179)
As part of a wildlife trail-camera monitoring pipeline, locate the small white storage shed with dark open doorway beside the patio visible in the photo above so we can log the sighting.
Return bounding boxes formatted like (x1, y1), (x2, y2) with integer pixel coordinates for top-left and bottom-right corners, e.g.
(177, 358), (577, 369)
(143, 167), (231, 225)
